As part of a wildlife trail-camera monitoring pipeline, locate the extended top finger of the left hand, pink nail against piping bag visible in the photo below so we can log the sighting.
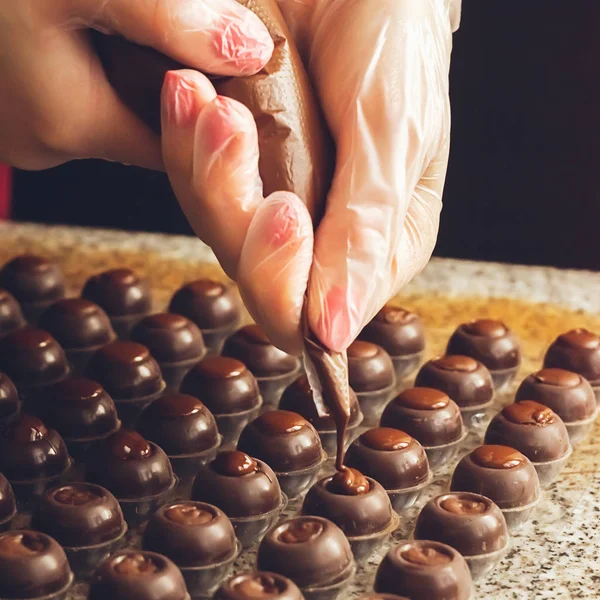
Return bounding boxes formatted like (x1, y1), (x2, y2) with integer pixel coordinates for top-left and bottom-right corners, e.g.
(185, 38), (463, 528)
(68, 0), (273, 75)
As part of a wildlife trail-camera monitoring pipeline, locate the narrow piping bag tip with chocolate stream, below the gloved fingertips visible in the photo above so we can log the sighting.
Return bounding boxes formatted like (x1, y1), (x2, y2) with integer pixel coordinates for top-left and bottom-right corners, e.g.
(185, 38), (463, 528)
(302, 299), (350, 471)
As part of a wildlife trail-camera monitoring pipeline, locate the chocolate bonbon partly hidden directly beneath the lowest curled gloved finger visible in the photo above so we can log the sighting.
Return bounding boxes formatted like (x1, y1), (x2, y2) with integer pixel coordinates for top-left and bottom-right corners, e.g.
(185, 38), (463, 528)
(223, 325), (300, 406)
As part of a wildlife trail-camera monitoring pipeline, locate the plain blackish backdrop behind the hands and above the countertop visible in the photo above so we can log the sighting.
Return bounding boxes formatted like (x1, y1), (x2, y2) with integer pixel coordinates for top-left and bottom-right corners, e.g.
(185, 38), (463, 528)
(13, 0), (600, 269)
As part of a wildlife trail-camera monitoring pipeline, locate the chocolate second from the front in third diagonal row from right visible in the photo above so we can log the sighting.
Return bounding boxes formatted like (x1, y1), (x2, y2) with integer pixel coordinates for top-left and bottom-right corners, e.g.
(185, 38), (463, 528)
(142, 500), (237, 567)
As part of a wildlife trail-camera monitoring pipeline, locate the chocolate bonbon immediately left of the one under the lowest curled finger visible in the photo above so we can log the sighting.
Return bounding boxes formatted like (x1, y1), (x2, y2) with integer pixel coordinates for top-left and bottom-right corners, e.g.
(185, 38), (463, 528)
(131, 313), (206, 391)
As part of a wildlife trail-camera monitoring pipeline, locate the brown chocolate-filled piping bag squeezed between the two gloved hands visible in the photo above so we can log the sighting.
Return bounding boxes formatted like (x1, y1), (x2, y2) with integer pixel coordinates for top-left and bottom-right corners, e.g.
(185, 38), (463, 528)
(92, 0), (350, 469)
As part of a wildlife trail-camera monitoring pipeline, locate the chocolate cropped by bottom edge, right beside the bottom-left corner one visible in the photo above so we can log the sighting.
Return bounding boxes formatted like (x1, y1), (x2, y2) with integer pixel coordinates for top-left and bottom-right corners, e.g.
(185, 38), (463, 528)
(88, 550), (189, 600)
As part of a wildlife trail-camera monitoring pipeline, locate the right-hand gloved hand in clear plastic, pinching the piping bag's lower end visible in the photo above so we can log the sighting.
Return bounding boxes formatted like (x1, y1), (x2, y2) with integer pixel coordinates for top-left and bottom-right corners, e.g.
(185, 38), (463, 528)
(163, 0), (452, 352)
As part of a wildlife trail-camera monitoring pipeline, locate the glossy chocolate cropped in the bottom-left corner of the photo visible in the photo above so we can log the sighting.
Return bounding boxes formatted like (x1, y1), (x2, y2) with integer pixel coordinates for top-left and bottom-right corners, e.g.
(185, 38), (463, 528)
(0, 530), (72, 599)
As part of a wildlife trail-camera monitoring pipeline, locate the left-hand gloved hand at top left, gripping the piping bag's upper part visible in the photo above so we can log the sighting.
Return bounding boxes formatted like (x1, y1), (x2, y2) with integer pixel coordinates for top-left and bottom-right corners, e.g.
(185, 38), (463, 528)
(0, 0), (273, 169)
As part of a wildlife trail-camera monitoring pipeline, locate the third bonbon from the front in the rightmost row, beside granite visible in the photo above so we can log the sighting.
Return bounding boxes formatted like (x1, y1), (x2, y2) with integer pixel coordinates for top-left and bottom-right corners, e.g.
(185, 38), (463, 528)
(450, 444), (541, 531)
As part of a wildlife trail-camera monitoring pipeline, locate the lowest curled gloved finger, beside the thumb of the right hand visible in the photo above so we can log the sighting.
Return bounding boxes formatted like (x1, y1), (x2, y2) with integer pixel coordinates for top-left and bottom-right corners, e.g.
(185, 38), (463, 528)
(237, 192), (313, 354)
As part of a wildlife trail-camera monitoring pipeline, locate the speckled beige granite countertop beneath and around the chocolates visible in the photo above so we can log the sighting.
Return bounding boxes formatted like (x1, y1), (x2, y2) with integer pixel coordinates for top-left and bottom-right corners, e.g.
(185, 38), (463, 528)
(0, 223), (600, 600)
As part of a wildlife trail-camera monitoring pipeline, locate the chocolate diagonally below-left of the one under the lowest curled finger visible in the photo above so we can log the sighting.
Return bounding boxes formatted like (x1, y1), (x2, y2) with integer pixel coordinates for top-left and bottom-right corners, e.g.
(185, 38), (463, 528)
(181, 356), (260, 415)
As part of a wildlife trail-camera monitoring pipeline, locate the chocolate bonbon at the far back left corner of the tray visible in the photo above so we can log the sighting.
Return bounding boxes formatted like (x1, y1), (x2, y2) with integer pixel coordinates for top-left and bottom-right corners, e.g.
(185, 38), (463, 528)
(0, 254), (65, 325)
